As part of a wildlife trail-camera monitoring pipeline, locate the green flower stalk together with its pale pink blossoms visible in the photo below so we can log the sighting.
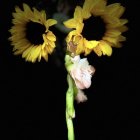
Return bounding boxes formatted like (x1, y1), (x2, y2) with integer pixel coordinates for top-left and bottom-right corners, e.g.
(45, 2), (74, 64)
(65, 54), (95, 140)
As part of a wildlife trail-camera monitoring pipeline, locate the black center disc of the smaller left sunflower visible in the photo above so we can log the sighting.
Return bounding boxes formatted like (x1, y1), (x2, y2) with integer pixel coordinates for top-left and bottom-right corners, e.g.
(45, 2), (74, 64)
(26, 21), (46, 45)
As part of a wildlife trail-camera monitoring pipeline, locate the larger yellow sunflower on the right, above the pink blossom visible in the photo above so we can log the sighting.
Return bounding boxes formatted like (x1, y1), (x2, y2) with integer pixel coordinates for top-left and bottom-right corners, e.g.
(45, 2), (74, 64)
(64, 0), (128, 56)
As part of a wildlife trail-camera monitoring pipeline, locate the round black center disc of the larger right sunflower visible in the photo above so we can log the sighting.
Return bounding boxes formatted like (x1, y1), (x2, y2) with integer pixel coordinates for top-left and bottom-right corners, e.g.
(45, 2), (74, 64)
(82, 16), (106, 40)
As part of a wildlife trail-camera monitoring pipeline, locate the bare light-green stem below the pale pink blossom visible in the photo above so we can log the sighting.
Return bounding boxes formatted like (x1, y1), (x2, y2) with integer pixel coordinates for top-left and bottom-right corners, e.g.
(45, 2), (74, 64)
(66, 74), (75, 140)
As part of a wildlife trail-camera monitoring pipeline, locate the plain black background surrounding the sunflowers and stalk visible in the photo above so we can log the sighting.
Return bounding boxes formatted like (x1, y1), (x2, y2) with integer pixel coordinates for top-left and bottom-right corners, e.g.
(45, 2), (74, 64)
(0, 0), (140, 140)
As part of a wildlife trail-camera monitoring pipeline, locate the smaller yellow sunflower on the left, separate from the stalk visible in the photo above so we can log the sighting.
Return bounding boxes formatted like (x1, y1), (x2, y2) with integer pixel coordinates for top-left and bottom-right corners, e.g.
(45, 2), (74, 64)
(9, 4), (57, 62)
